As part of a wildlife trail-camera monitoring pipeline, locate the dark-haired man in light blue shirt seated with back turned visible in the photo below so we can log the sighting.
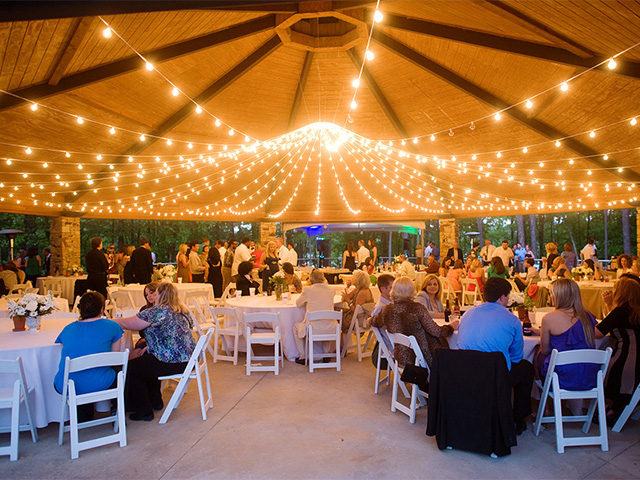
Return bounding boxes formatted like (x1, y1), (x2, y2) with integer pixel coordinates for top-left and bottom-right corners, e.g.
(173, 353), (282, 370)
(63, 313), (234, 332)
(458, 277), (534, 435)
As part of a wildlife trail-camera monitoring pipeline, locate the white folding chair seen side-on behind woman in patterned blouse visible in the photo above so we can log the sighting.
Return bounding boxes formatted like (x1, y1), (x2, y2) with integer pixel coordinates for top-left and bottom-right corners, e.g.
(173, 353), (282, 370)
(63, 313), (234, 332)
(158, 330), (213, 424)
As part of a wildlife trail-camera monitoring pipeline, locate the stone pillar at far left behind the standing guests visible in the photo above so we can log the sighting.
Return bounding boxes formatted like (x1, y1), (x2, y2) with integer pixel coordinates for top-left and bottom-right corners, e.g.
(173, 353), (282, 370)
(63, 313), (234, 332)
(50, 217), (82, 274)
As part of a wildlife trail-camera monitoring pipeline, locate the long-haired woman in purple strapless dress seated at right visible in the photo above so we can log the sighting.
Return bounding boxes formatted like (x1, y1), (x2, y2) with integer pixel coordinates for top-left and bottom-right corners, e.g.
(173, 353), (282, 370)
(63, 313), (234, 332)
(536, 278), (600, 390)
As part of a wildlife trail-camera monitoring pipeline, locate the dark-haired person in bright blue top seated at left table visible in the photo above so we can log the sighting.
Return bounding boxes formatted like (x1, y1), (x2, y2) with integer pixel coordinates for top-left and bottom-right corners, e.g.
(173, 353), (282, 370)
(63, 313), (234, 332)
(53, 292), (124, 422)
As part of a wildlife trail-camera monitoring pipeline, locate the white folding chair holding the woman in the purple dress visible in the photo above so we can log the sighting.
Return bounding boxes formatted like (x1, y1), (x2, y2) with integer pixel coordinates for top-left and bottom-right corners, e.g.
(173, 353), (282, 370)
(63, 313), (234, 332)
(534, 348), (611, 453)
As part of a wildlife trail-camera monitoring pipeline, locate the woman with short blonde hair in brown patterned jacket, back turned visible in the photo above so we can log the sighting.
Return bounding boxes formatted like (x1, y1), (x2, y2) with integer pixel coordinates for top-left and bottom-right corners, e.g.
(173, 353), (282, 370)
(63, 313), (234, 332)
(371, 277), (456, 367)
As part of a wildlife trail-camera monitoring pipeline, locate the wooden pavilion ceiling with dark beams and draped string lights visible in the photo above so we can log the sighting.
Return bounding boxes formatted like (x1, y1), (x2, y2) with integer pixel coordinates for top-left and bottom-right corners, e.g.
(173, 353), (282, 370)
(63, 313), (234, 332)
(0, 0), (640, 222)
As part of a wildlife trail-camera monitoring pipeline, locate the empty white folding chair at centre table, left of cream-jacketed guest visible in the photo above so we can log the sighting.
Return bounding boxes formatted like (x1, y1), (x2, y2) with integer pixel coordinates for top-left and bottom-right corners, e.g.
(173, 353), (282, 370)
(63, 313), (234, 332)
(244, 312), (284, 375)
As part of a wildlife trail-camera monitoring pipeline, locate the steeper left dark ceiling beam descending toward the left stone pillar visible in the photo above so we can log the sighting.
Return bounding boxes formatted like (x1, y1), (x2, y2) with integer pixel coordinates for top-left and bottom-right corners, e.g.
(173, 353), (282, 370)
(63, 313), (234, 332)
(65, 35), (282, 204)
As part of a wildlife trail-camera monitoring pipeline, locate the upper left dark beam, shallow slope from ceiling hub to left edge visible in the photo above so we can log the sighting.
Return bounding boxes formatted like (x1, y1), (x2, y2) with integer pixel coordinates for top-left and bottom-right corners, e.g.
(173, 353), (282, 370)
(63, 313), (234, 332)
(0, 14), (276, 112)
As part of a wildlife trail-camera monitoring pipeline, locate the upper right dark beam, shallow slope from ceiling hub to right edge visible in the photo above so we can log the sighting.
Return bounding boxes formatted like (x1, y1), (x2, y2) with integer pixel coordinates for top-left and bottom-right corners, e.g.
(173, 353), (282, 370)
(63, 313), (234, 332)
(383, 13), (640, 79)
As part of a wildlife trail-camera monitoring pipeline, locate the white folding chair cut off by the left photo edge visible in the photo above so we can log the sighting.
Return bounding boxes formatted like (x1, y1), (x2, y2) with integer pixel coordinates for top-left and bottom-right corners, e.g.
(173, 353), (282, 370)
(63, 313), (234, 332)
(0, 357), (38, 462)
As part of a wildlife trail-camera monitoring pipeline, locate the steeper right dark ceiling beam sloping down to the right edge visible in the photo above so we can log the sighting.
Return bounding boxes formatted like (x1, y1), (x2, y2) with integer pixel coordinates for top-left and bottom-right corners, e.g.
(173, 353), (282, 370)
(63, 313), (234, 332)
(373, 30), (640, 182)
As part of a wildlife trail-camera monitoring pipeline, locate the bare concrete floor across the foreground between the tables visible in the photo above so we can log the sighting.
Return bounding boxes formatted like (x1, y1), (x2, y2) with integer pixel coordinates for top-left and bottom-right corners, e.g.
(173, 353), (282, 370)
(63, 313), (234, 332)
(0, 354), (640, 479)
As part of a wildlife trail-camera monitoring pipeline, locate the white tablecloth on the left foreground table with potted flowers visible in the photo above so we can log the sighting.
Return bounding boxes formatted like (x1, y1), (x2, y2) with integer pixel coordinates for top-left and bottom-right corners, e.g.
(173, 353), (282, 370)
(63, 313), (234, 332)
(0, 314), (76, 428)
